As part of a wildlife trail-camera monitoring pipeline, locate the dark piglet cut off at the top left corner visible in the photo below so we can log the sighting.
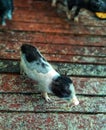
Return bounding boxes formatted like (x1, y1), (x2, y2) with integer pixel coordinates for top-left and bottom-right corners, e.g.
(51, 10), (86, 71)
(0, 0), (14, 26)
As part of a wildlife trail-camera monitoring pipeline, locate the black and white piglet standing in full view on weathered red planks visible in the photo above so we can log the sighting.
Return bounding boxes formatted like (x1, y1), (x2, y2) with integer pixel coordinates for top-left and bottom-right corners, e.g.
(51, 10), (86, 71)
(20, 44), (79, 105)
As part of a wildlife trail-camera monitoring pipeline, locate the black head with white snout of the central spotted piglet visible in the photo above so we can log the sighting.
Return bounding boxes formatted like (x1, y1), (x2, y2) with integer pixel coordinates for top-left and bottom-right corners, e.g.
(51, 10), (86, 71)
(51, 76), (79, 105)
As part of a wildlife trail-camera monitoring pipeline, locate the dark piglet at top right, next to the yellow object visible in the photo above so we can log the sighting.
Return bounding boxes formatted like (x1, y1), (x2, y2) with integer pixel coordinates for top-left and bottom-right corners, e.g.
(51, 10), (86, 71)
(67, 0), (106, 21)
